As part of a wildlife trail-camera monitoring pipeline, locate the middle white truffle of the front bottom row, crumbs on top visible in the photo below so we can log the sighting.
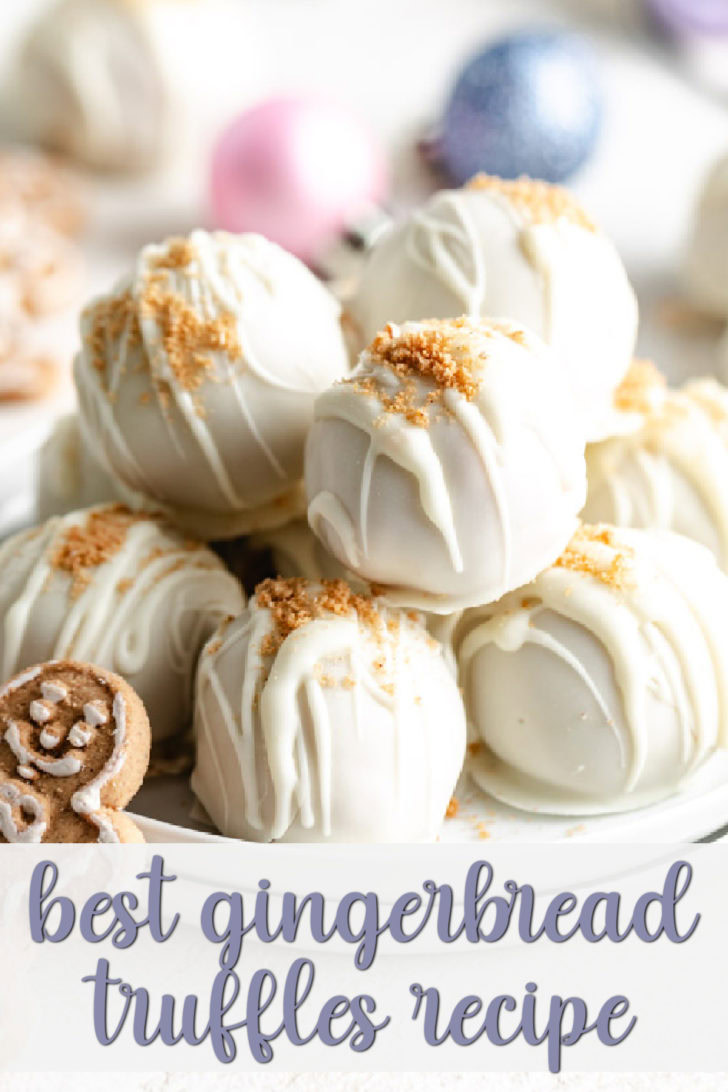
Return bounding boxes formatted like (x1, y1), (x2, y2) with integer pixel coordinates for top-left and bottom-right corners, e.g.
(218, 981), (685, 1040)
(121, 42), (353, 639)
(192, 580), (465, 842)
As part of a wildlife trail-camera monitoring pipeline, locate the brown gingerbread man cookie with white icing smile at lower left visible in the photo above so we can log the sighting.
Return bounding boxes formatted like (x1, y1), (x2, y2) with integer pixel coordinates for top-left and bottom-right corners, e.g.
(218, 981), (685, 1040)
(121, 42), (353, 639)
(0, 660), (151, 842)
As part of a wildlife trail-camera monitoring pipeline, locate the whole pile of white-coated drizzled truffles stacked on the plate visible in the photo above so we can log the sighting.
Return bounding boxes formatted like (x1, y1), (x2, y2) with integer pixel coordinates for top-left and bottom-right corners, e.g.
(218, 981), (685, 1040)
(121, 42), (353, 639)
(8, 170), (728, 841)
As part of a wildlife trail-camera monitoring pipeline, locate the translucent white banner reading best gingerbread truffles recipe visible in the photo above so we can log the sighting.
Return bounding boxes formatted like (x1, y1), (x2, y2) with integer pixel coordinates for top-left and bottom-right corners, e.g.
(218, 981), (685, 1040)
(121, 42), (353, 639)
(0, 843), (728, 1072)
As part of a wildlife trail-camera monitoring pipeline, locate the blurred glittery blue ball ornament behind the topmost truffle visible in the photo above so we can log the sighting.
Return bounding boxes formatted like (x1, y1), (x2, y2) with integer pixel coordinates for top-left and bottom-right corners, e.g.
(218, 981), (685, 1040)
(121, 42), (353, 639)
(445, 31), (602, 183)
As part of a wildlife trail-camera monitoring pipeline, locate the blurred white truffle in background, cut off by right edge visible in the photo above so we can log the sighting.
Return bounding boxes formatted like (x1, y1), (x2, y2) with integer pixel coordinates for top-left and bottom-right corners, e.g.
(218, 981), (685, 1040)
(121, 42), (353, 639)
(683, 155), (728, 319)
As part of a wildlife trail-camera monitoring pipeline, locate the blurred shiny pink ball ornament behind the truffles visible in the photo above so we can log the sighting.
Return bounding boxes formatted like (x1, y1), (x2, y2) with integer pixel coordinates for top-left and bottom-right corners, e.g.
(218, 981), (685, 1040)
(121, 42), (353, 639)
(211, 97), (386, 262)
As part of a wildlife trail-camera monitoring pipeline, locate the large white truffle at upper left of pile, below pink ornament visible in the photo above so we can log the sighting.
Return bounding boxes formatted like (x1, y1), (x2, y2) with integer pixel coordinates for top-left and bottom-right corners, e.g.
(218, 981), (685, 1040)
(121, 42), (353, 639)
(74, 232), (348, 539)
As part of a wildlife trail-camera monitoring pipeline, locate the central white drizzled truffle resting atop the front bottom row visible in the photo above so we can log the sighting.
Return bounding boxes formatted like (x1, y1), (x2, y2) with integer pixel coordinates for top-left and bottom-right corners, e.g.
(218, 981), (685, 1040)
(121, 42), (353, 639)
(306, 319), (586, 614)
